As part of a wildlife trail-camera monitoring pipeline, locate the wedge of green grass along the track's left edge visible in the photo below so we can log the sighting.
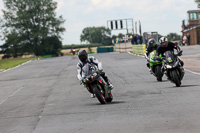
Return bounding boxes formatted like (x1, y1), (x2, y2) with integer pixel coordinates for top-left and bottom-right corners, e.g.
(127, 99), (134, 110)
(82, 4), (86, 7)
(0, 57), (38, 71)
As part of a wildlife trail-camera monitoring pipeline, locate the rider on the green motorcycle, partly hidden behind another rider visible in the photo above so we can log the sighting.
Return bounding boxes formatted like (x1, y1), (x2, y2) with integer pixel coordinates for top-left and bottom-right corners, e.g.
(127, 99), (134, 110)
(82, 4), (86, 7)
(144, 38), (158, 73)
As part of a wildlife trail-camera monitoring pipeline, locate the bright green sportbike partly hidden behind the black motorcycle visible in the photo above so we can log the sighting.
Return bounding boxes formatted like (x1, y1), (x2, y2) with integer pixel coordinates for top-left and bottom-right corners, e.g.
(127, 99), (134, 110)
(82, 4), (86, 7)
(149, 50), (163, 81)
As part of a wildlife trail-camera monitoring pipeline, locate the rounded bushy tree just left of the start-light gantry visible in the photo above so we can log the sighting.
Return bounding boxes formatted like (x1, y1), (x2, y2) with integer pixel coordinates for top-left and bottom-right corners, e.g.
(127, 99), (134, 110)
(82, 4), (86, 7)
(80, 27), (112, 45)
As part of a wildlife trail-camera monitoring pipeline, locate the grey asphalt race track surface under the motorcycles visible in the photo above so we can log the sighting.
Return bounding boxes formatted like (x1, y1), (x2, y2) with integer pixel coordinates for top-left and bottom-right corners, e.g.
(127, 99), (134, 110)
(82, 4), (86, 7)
(0, 50), (200, 133)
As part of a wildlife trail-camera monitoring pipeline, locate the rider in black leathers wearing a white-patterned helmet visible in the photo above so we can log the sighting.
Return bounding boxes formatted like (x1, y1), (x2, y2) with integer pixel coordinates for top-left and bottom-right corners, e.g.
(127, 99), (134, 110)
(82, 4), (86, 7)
(156, 37), (184, 74)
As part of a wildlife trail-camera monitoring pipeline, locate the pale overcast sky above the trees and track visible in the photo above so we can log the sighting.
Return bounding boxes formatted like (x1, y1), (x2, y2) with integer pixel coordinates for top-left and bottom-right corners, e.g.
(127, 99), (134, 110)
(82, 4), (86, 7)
(0, 0), (198, 45)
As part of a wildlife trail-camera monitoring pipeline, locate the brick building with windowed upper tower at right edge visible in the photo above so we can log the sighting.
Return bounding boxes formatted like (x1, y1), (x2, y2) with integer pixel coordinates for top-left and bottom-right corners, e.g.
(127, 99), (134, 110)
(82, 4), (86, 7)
(182, 10), (200, 45)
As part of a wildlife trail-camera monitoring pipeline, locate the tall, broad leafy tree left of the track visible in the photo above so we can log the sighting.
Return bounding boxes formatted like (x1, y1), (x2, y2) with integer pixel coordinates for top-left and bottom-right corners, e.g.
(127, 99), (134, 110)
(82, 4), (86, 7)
(1, 0), (65, 55)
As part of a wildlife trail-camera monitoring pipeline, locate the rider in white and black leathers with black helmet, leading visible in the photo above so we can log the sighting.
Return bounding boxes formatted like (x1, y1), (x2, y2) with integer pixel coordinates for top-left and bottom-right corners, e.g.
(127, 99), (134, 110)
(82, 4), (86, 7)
(77, 49), (113, 98)
